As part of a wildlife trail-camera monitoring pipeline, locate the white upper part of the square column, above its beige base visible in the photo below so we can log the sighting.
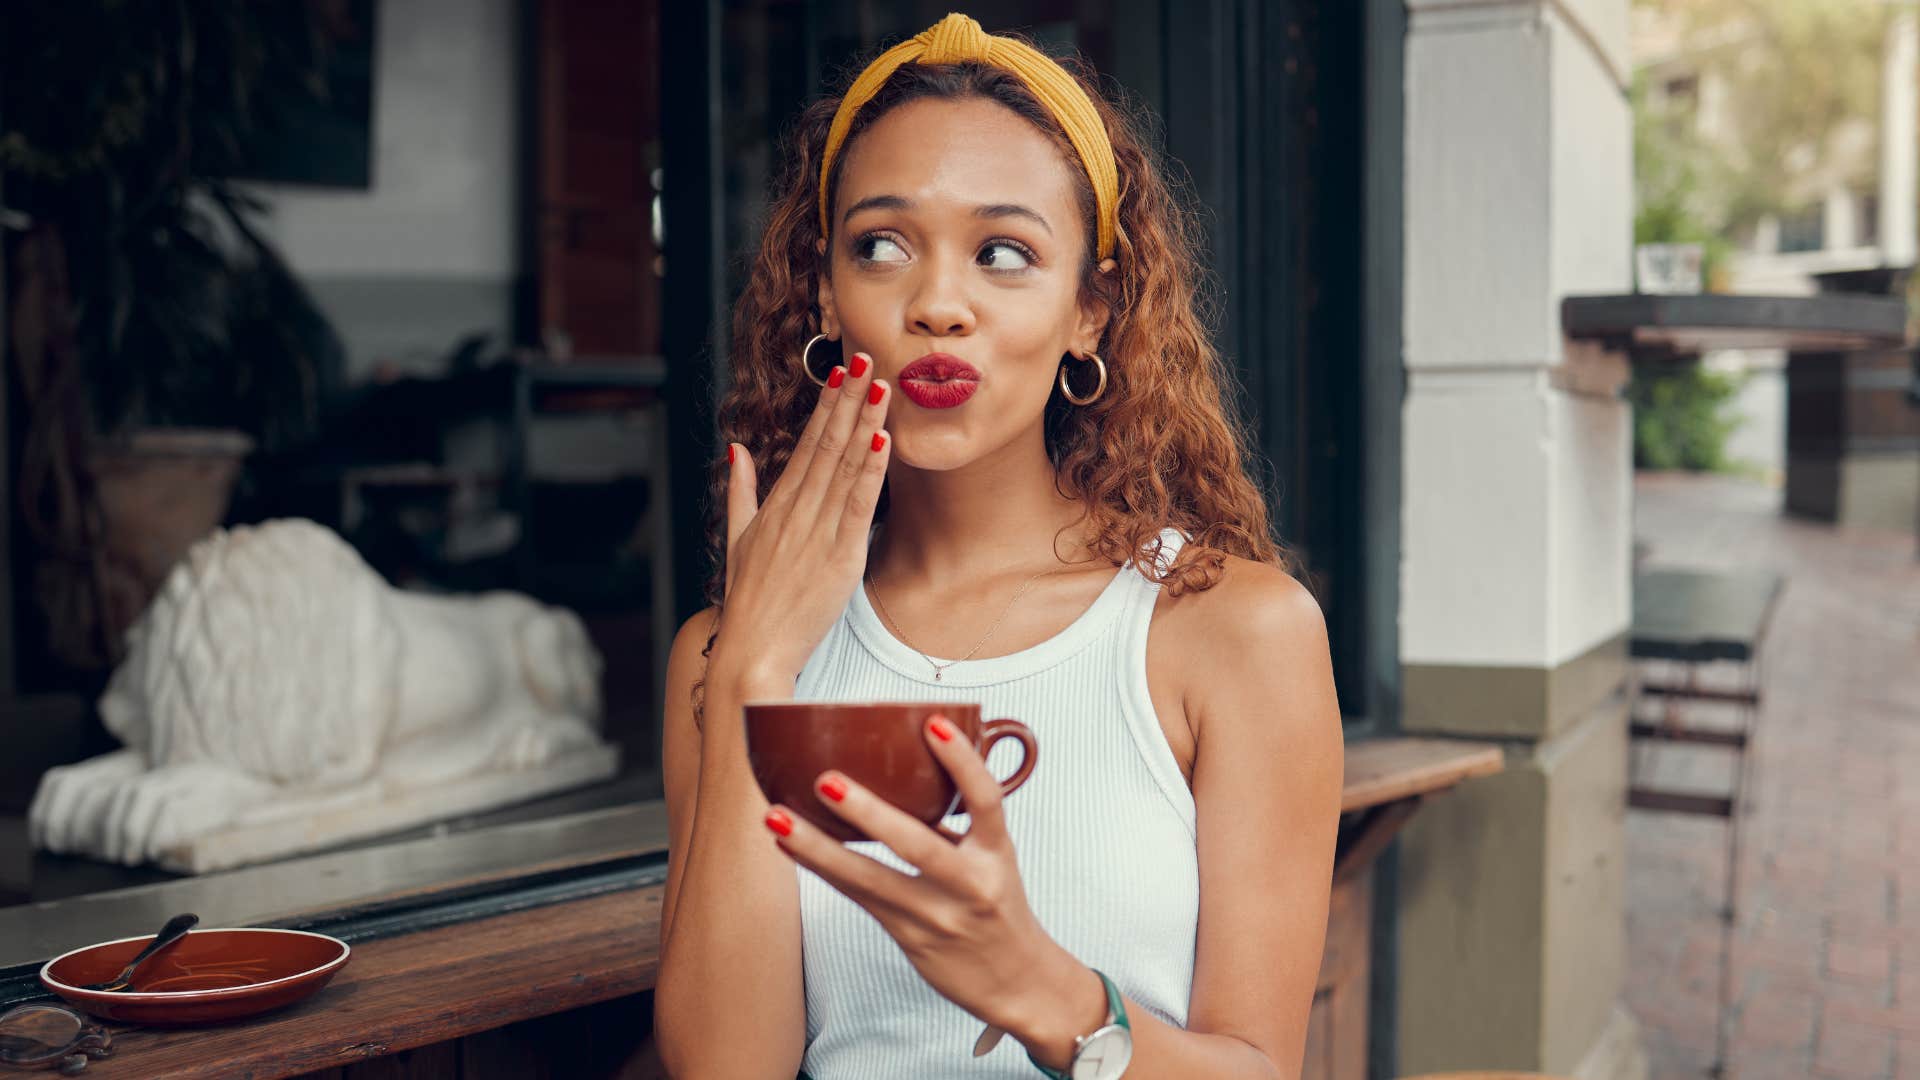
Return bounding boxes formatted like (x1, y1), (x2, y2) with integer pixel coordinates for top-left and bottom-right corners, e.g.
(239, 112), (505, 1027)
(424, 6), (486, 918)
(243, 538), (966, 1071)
(1400, 0), (1634, 667)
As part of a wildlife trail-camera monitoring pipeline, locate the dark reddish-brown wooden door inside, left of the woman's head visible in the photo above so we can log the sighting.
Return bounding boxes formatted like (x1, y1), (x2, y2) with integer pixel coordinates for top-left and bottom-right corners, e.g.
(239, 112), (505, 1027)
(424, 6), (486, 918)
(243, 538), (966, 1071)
(536, 0), (664, 361)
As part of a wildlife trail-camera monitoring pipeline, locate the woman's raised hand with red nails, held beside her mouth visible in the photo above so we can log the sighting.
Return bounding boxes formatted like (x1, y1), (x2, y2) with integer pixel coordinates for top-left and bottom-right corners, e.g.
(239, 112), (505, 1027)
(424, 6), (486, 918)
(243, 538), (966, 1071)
(708, 354), (893, 682)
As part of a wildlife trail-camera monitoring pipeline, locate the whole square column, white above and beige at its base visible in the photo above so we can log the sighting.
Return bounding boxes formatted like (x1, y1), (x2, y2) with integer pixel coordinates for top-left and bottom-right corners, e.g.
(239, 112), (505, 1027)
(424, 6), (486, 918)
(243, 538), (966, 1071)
(1398, 0), (1645, 1080)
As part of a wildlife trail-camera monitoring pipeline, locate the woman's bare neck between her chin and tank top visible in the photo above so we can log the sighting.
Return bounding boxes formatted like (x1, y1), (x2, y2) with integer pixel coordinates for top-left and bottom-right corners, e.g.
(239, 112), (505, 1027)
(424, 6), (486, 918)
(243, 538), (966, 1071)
(870, 430), (1087, 592)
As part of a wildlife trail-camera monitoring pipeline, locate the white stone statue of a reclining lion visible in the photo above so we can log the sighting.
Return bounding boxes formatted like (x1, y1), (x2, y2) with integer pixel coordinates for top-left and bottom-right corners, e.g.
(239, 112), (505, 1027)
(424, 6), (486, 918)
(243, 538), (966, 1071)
(29, 519), (618, 872)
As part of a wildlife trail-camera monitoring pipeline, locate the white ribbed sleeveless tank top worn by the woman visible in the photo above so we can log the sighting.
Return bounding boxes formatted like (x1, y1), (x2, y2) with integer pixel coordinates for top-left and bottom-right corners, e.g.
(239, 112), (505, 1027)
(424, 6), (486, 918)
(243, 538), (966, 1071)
(795, 528), (1200, 1080)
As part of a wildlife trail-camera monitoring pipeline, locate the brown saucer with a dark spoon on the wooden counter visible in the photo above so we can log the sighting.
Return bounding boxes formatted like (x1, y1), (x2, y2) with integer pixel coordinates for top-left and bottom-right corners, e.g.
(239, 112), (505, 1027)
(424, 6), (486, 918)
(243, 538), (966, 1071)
(40, 928), (353, 1024)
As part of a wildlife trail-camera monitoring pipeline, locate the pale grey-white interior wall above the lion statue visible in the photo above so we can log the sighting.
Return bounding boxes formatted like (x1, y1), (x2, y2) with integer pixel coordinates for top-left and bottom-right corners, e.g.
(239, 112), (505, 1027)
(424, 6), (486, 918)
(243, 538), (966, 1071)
(255, 0), (522, 380)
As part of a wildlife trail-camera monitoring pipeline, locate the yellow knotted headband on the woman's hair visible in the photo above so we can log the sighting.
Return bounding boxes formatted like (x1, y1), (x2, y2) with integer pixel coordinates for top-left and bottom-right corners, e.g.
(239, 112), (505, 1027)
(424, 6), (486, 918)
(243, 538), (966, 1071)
(820, 13), (1119, 259)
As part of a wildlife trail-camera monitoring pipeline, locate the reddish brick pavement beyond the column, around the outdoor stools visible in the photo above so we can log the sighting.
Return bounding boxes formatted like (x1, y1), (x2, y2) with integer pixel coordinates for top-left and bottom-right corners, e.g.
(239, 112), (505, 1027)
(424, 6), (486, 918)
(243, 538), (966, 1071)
(1626, 475), (1920, 1080)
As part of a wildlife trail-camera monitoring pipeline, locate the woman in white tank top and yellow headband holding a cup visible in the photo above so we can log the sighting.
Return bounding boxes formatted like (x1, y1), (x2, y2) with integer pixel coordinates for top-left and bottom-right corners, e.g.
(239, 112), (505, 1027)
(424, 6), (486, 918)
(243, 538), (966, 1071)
(655, 15), (1342, 1080)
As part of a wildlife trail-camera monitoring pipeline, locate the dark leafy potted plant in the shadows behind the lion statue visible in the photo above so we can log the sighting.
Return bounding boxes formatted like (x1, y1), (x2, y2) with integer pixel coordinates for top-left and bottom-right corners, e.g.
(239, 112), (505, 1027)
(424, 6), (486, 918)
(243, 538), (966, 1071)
(0, 0), (342, 671)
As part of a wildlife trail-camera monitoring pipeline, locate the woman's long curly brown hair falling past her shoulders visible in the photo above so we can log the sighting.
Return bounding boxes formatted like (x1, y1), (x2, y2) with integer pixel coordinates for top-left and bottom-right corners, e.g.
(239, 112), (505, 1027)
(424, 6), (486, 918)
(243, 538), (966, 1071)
(707, 42), (1292, 605)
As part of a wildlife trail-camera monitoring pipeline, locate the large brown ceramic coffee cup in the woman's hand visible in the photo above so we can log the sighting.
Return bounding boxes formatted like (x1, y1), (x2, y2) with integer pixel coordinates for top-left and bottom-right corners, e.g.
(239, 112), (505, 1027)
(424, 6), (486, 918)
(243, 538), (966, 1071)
(747, 701), (1041, 840)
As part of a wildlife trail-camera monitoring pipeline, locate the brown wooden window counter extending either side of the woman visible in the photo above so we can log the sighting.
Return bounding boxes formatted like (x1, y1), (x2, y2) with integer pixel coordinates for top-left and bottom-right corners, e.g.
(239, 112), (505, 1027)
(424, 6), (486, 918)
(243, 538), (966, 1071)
(22, 738), (1501, 1080)
